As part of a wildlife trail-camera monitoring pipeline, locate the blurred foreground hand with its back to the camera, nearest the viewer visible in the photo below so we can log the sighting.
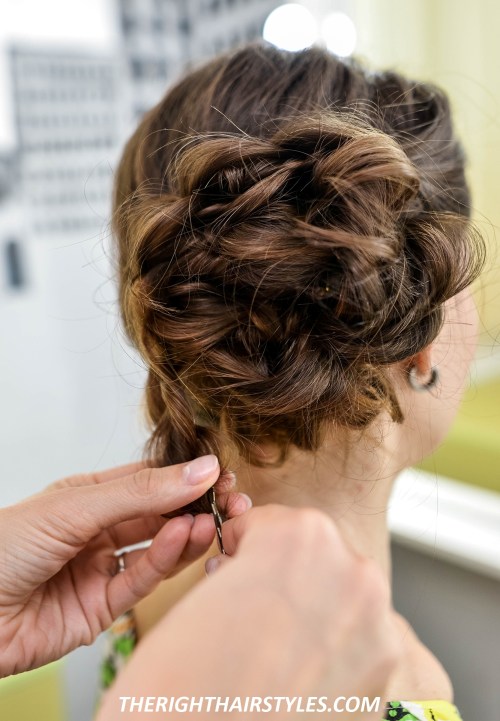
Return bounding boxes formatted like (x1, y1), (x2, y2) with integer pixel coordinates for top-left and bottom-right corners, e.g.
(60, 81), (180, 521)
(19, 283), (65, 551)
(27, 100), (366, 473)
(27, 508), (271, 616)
(97, 505), (399, 721)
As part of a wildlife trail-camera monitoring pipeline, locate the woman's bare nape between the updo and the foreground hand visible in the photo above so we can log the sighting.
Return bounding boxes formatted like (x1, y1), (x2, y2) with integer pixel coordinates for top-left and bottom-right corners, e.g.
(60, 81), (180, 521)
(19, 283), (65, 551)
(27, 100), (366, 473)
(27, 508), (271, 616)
(231, 424), (399, 586)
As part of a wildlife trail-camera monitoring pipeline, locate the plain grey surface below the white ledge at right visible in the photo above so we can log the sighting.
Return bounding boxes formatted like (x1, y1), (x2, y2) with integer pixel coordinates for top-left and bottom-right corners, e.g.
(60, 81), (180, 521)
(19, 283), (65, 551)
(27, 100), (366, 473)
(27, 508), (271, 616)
(392, 544), (500, 721)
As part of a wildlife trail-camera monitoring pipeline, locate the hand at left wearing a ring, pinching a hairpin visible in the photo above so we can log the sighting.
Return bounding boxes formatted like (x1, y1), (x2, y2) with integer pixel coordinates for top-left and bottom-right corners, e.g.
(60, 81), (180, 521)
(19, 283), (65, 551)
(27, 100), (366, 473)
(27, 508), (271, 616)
(0, 456), (248, 676)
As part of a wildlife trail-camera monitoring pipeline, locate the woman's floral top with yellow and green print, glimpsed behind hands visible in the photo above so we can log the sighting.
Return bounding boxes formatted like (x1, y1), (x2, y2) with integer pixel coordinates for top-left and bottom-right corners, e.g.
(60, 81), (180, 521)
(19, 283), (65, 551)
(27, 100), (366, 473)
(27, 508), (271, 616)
(101, 611), (462, 721)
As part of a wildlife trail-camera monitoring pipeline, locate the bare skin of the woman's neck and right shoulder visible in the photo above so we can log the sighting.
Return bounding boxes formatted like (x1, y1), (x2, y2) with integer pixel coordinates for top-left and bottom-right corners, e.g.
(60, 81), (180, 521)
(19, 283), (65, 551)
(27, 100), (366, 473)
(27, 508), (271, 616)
(230, 422), (453, 701)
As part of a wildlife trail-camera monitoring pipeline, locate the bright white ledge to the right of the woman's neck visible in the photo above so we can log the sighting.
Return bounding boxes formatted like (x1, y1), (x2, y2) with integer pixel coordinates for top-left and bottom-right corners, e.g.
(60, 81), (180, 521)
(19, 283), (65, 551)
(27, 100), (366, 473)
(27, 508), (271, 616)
(388, 469), (500, 580)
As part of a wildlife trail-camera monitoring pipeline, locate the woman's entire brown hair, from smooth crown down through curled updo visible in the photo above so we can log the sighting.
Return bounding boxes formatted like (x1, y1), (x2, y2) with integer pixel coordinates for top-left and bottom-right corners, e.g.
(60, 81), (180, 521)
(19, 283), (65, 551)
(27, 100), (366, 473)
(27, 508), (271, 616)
(113, 43), (484, 510)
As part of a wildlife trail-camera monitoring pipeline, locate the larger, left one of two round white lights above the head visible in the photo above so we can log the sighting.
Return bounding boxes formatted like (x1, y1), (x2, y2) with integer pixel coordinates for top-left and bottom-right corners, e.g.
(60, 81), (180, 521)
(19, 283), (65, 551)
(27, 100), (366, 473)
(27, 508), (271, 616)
(262, 3), (318, 50)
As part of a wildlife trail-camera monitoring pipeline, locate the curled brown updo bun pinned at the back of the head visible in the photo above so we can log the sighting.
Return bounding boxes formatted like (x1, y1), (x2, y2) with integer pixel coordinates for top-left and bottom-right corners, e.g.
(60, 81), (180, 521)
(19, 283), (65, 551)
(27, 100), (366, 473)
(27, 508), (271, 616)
(120, 112), (484, 472)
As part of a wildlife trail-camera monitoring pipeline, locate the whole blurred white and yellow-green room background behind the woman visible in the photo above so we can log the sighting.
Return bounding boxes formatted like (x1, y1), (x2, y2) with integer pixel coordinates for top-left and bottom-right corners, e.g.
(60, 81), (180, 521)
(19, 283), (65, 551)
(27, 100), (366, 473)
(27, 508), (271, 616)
(0, 0), (500, 721)
